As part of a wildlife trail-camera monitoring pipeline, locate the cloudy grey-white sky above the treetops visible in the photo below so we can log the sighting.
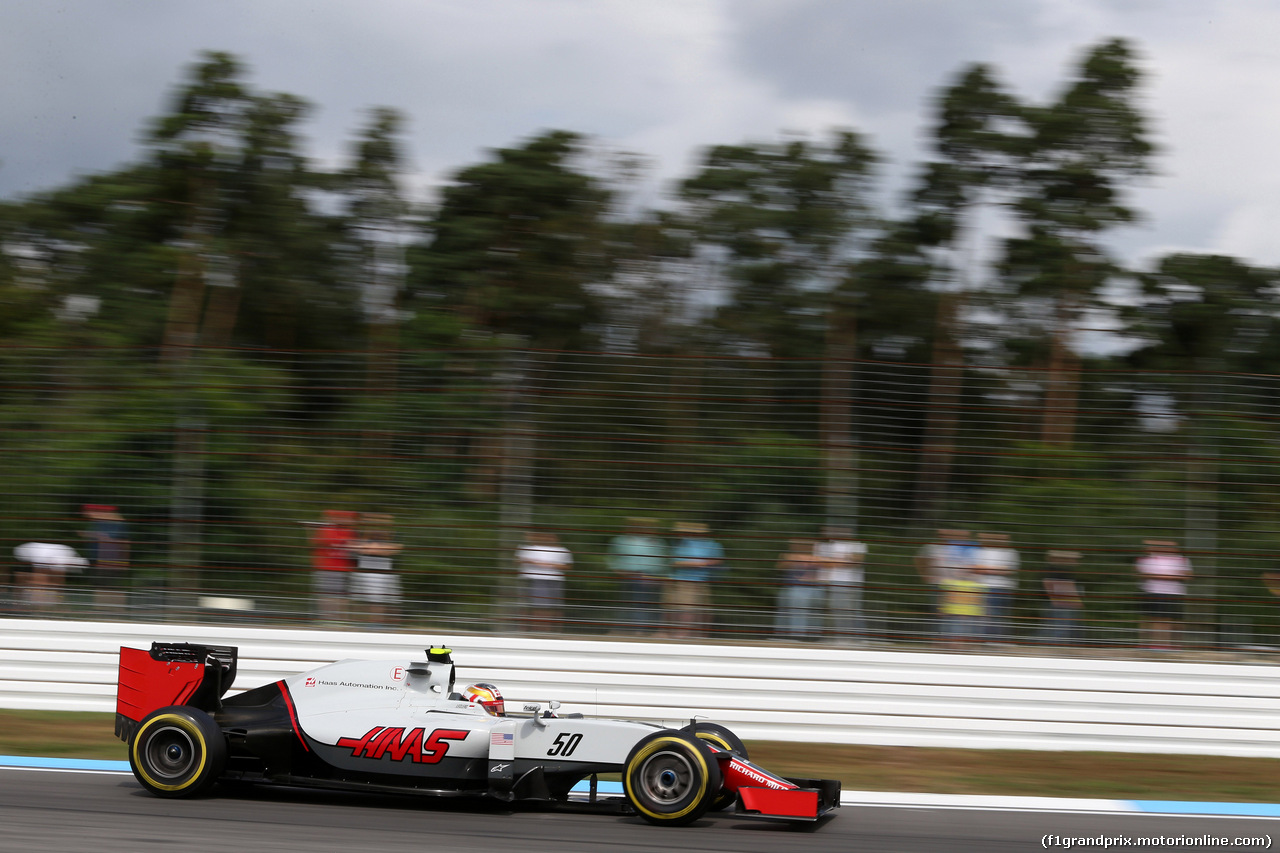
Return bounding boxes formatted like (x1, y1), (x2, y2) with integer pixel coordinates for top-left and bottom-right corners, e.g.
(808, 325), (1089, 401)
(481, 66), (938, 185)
(0, 0), (1280, 264)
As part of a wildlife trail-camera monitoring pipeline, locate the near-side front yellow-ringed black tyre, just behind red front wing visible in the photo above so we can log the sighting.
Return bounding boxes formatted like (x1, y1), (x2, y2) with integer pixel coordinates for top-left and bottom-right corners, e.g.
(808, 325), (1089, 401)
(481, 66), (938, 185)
(622, 730), (723, 826)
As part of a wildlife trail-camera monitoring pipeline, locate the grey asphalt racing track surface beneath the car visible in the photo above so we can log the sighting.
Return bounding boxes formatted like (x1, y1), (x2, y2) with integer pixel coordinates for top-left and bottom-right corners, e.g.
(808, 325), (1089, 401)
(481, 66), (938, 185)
(0, 770), (1280, 853)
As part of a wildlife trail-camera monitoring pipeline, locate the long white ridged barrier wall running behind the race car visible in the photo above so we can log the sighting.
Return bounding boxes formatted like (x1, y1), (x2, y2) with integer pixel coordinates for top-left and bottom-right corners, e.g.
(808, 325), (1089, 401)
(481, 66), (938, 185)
(0, 620), (1280, 758)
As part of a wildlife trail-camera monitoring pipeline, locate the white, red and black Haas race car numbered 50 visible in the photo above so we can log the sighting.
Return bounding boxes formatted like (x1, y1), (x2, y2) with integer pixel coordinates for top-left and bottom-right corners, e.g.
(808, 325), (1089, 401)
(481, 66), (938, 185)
(115, 643), (840, 826)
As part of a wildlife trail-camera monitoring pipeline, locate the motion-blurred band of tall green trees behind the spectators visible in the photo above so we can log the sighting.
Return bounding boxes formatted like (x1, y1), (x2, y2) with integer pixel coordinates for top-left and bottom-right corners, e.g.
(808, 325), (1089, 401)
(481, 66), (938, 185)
(0, 40), (1280, 637)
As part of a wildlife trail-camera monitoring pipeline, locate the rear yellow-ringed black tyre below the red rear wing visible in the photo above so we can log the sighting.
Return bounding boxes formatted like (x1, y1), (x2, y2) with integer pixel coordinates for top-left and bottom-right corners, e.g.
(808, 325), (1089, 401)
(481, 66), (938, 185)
(129, 706), (227, 797)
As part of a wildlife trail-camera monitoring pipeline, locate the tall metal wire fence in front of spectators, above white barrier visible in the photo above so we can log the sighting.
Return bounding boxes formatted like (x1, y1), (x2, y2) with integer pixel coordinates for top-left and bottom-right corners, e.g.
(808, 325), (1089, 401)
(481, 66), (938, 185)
(0, 346), (1280, 647)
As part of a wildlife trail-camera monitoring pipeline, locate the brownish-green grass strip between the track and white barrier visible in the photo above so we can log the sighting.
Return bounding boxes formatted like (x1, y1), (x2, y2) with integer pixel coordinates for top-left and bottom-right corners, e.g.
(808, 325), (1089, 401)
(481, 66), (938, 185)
(10, 711), (1280, 803)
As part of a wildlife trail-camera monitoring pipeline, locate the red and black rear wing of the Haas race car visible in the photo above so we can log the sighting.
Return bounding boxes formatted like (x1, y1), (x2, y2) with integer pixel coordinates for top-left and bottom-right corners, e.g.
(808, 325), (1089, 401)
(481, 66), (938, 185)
(115, 643), (239, 743)
